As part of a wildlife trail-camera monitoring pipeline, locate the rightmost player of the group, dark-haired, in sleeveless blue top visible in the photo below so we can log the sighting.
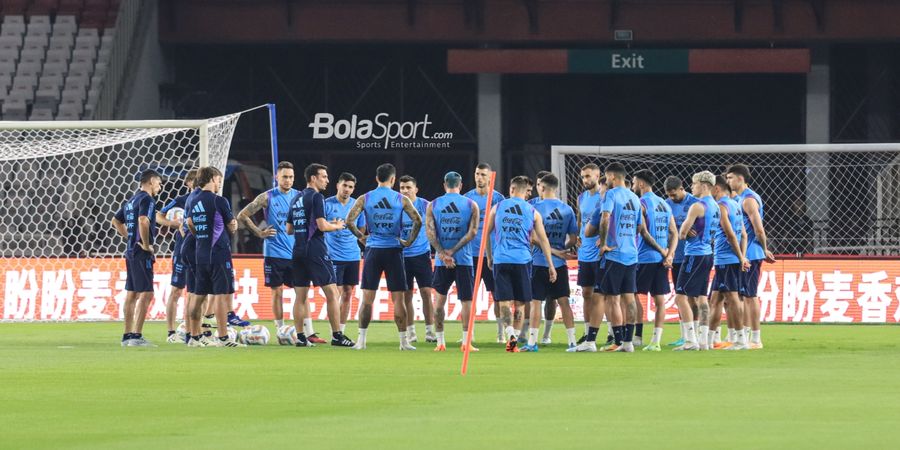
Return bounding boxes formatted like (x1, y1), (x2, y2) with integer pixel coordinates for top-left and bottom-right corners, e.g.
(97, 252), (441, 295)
(725, 164), (775, 349)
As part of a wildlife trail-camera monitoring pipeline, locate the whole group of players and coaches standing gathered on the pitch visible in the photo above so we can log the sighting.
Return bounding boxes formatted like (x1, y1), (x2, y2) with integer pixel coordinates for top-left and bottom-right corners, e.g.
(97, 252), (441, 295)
(112, 157), (774, 352)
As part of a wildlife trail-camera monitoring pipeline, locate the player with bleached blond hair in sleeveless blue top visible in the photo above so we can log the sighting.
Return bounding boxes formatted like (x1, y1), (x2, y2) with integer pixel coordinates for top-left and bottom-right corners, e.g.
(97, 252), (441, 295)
(675, 170), (720, 350)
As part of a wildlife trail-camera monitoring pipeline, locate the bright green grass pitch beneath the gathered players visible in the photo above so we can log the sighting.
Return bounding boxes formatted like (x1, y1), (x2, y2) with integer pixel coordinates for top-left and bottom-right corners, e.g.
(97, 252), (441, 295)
(0, 323), (900, 450)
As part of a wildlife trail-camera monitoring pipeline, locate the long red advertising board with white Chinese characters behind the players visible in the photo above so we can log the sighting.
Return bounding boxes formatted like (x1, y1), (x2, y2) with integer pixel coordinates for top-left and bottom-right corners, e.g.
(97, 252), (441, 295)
(0, 257), (900, 323)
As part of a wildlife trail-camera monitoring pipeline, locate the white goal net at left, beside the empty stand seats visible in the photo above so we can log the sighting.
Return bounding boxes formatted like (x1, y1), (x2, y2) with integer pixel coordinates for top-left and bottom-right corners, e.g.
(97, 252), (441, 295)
(0, 113), (241, 320)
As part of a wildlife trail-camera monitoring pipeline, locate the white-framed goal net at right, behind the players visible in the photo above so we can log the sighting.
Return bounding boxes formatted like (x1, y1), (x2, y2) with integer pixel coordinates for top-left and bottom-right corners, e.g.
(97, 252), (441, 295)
(552, 144), (900, 256)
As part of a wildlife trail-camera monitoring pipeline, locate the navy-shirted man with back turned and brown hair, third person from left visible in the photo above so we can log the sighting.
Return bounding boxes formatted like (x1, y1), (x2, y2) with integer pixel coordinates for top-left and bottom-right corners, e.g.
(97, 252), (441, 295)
(187, 167), (243, 347)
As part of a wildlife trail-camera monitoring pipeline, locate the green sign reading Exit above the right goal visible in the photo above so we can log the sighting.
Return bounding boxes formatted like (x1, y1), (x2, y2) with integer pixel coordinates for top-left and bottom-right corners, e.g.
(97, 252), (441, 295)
(569, 49), (688, 74)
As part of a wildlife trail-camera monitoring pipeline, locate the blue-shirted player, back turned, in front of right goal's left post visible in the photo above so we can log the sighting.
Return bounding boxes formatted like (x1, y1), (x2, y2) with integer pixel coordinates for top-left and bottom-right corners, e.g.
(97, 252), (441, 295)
(522, 174), (578, 351)
